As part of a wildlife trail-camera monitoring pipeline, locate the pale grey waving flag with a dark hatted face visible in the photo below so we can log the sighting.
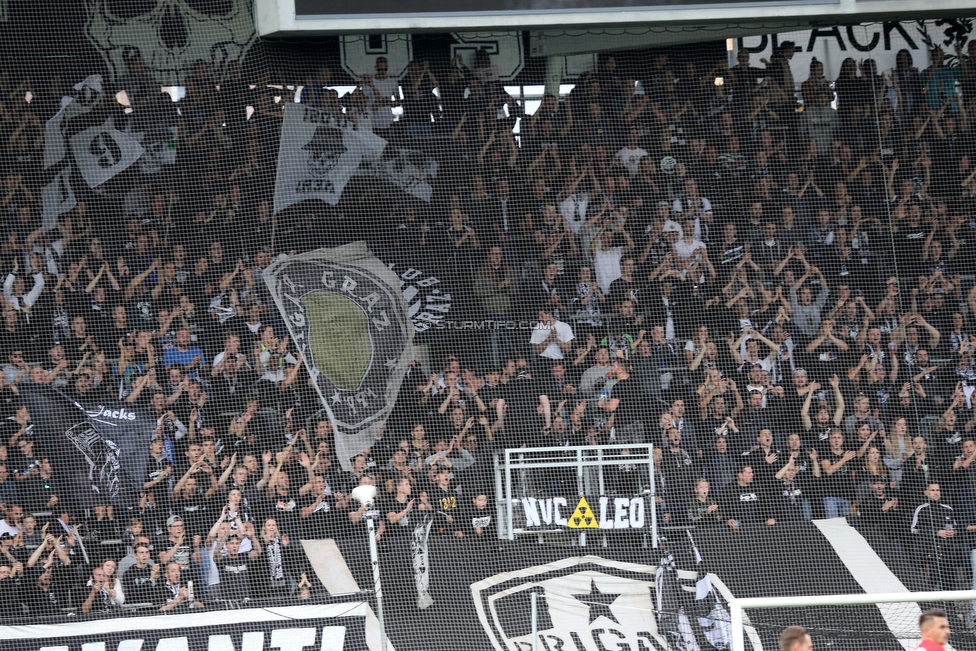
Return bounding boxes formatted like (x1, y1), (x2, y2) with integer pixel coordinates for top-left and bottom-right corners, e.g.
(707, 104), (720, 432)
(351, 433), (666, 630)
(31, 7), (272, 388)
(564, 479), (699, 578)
(274, 103), (386, 213)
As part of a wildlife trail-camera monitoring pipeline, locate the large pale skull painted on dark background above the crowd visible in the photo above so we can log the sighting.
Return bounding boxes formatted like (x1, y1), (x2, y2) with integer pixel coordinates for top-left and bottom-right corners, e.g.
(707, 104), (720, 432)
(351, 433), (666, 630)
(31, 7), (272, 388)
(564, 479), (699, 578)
(85, 0), (256, 85)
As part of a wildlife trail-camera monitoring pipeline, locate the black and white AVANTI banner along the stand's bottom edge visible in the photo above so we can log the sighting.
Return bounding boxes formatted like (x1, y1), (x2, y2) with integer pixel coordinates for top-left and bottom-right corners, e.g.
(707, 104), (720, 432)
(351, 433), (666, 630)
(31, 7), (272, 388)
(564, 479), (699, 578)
(0, 602), (367, 651)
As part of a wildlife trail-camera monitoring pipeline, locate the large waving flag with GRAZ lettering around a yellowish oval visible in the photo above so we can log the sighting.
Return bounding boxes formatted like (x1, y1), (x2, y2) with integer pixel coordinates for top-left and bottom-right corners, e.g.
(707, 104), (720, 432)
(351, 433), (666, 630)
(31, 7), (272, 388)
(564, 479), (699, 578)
(263, 242), (414, 470)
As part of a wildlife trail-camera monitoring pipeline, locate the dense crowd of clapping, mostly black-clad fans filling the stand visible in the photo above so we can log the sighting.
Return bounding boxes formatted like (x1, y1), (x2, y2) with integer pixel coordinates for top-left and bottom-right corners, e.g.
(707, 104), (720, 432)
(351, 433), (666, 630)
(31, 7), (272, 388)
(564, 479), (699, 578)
(0, 41), (976, 618)
